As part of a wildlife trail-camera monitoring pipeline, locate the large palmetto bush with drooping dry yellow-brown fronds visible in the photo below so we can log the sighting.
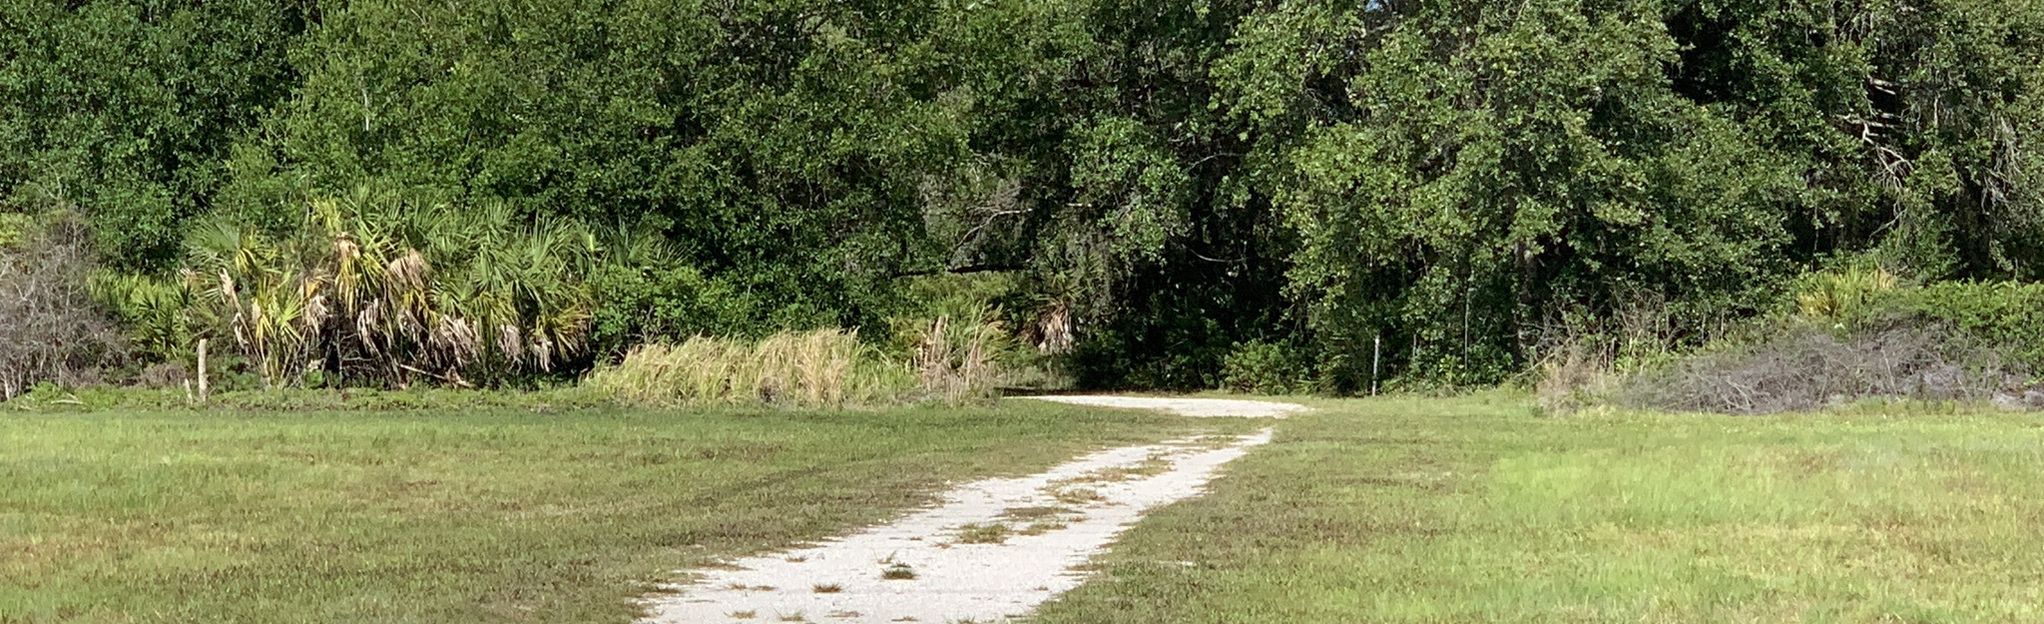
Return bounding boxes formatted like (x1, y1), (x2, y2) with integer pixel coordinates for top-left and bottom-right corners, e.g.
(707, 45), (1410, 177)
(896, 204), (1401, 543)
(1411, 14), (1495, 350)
(182, 190), (599, 387)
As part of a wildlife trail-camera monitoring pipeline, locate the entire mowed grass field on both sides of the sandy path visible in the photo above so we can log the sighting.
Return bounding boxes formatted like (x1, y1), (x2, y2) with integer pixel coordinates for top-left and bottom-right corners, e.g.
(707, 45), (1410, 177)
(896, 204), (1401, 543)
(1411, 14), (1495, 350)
(0, 393), (2044, 624)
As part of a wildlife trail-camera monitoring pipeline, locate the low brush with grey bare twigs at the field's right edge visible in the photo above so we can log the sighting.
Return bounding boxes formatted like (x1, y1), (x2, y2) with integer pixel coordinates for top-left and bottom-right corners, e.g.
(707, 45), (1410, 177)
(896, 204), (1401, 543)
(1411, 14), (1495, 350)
(1533, 266), (2044, 413)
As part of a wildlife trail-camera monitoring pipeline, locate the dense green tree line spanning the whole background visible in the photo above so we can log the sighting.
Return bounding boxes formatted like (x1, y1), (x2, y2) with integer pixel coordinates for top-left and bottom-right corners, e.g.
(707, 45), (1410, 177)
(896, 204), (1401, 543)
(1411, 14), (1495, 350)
(0, 0), (2044, 391)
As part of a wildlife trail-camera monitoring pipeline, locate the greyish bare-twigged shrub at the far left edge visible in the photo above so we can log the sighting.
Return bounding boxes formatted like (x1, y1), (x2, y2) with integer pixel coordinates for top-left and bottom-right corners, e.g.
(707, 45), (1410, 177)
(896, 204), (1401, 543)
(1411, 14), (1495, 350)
(0, 217), (121, 399)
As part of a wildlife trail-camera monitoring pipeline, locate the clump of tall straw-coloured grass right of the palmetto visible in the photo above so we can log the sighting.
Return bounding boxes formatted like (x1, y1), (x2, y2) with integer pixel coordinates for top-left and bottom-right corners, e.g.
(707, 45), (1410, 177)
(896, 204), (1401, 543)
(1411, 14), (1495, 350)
(587, 329), (916, 407)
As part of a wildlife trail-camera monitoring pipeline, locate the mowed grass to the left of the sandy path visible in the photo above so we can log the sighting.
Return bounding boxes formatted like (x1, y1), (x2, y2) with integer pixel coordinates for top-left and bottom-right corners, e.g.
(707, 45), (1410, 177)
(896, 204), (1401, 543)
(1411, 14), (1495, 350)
(0, 401), (1245, 624)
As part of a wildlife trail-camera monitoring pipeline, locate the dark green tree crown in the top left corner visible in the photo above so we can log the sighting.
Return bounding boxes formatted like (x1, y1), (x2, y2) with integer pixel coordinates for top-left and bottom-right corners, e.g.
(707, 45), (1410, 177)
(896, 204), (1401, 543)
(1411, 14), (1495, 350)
(0, 0), (315, 268)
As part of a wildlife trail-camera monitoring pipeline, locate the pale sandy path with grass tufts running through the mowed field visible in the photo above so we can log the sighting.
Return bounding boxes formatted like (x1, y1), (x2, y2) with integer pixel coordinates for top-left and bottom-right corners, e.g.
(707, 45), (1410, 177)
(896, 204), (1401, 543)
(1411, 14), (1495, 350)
(644, 399), (1296, 624)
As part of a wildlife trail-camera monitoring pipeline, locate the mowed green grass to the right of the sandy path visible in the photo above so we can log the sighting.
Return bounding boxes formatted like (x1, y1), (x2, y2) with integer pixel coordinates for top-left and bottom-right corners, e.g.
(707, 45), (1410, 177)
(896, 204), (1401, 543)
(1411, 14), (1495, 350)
(1032, 393), (2044, 624)
